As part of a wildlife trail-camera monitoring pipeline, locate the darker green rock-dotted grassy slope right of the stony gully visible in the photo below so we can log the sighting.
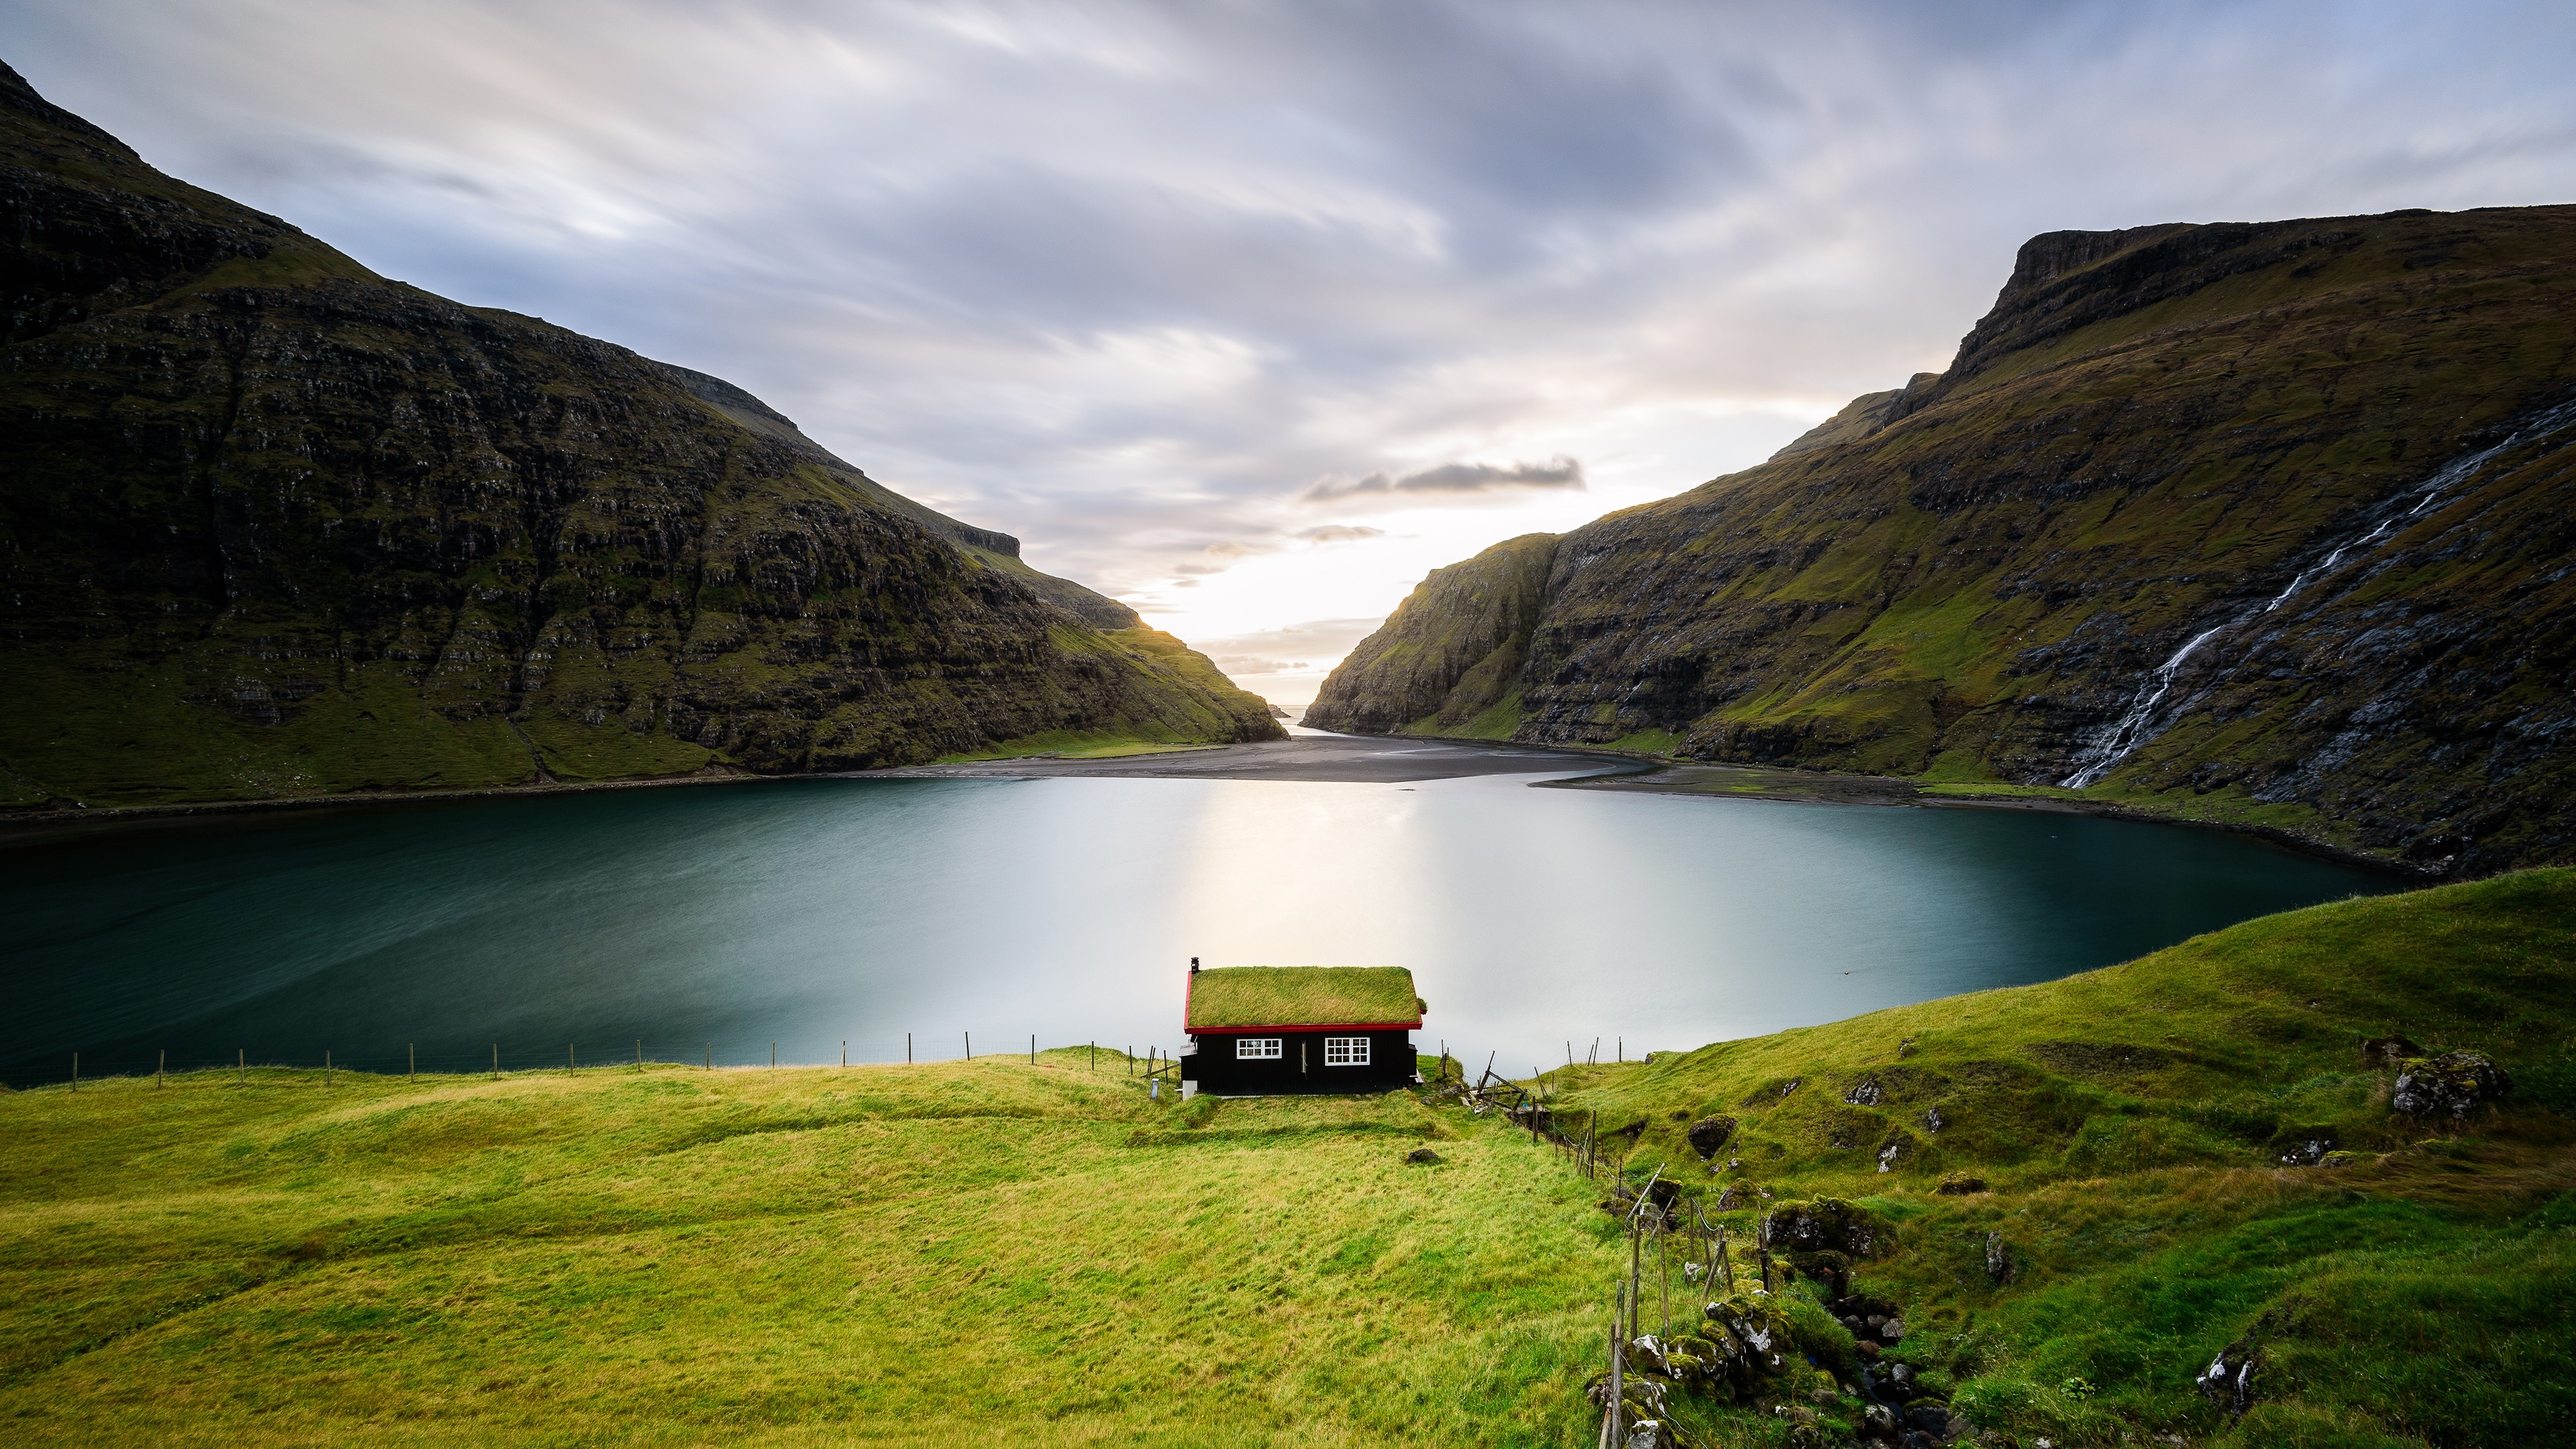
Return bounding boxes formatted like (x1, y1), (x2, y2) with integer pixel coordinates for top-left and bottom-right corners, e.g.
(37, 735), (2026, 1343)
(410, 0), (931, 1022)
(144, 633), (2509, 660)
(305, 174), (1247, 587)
(1548, 871), (2576, 1446)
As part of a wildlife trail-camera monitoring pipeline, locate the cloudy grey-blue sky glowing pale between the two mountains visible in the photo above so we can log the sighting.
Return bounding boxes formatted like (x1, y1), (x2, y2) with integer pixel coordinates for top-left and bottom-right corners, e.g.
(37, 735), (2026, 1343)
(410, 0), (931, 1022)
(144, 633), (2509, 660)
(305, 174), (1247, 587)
(0, 0), (2576, 709)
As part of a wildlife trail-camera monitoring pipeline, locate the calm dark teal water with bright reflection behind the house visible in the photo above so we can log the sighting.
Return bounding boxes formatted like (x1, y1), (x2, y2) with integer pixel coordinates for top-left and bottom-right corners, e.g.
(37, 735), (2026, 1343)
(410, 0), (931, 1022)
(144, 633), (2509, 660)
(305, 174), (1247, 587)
(0, 776), (2396, 1083)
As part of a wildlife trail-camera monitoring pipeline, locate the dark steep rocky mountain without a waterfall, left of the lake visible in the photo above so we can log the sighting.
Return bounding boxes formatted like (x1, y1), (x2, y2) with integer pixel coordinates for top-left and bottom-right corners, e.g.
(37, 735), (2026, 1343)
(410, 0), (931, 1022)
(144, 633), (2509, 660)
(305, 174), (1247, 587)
(0, 67), (1280, 807)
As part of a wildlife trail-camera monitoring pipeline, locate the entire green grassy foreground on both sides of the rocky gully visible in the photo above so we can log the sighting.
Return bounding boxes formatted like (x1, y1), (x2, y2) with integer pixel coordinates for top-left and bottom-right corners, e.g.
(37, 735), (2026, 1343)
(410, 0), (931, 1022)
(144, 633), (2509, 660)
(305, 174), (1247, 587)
(0, 871), (2576, 1446)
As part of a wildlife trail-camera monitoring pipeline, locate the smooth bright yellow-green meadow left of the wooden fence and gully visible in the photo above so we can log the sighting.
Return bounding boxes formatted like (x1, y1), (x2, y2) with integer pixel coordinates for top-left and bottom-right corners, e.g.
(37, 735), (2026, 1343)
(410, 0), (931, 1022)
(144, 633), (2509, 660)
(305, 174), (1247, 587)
(0, 1052), (1615, 1446)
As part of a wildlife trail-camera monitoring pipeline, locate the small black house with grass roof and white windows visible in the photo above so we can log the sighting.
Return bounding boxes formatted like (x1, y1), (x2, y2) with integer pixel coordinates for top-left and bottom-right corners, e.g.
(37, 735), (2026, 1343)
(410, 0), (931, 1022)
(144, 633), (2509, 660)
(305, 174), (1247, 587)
(1180, 959), (1425, 1095)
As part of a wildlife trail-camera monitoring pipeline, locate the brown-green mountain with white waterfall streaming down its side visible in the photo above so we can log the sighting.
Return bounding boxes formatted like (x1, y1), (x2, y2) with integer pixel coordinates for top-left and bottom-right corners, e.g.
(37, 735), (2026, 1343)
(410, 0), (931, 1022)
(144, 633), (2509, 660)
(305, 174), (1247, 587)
(1306, 206), (2576, 871)
